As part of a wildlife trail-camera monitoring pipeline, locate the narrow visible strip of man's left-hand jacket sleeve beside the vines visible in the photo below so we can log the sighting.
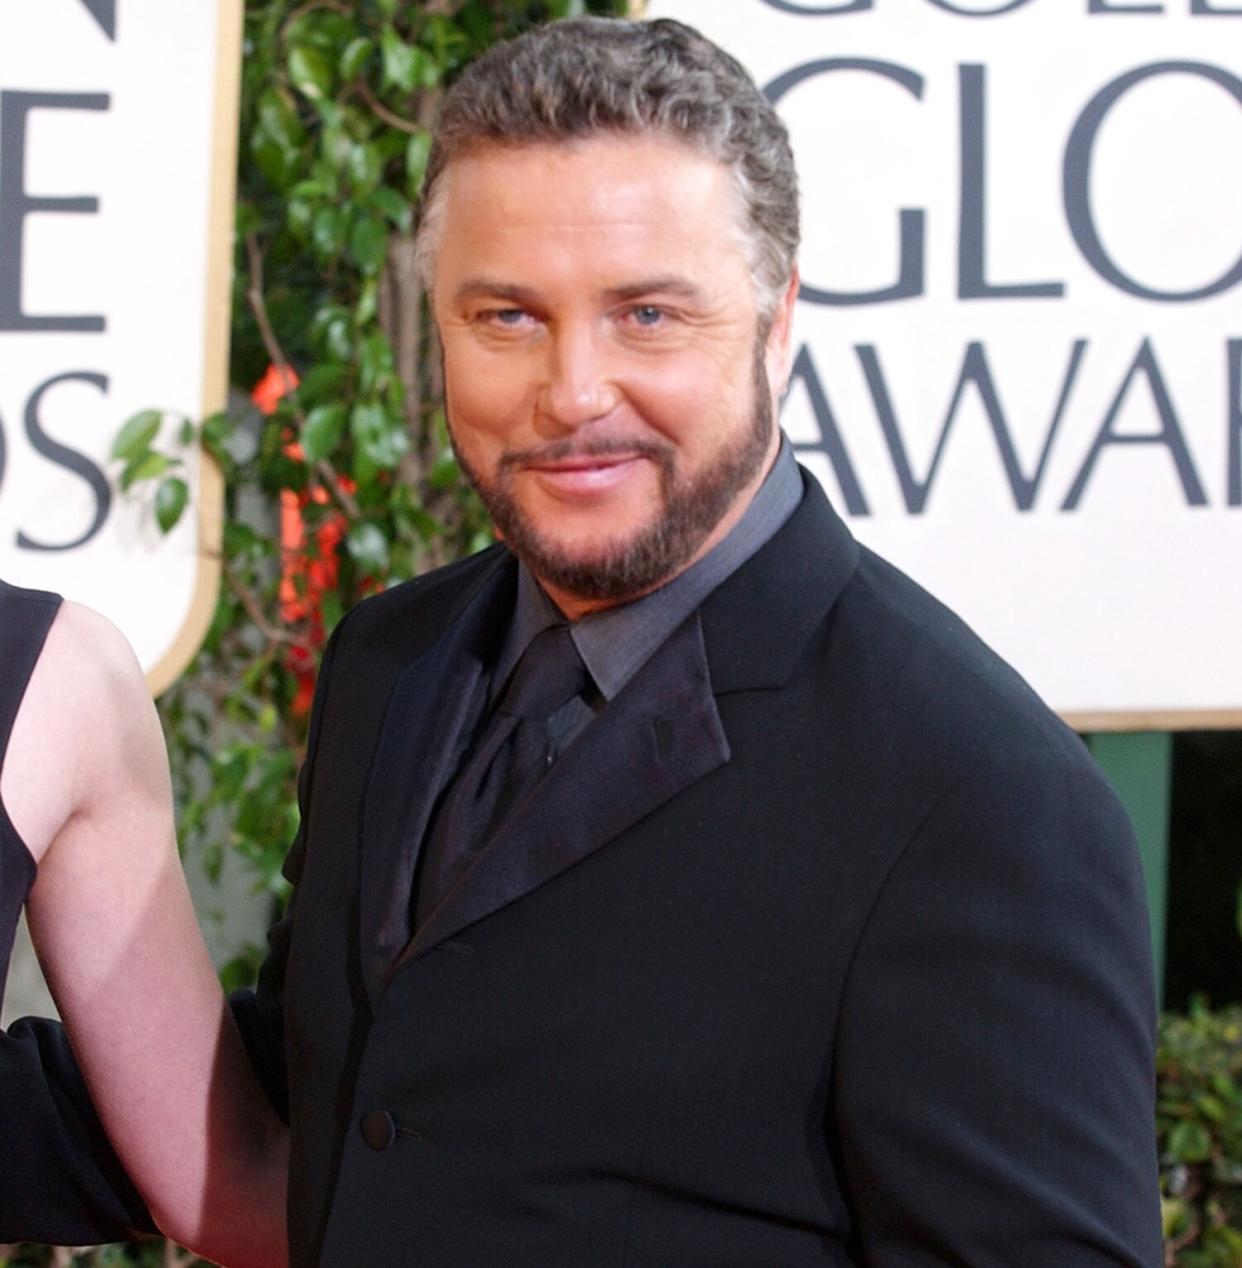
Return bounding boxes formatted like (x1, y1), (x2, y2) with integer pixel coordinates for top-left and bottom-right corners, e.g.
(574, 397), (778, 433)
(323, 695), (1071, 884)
(228, 612), (350, 1122)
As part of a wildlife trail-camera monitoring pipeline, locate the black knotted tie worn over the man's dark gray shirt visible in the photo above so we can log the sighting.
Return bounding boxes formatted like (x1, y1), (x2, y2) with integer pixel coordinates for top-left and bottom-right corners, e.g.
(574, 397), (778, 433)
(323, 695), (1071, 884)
(414, 625), (587, 928)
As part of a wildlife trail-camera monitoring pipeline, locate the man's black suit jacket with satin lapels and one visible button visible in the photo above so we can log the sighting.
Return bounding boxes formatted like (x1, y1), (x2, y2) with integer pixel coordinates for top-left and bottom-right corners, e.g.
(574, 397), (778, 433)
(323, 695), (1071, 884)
(235, 482), (1161, 1268)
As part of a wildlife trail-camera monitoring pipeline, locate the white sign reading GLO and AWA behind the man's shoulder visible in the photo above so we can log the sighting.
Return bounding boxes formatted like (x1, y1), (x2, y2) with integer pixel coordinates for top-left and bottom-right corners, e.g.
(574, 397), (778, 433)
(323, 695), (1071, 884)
(647, 0), (1242, 728)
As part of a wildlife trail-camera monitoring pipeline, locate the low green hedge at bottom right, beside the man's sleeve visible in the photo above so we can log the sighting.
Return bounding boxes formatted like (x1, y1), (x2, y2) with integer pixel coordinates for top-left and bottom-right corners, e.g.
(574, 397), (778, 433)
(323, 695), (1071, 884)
(1156, 999), (1242, 1268)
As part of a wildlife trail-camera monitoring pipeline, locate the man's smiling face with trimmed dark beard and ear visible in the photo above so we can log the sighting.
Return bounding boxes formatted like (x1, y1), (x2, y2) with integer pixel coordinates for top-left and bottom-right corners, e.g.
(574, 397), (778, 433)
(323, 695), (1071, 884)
(433, 137), (793, 616)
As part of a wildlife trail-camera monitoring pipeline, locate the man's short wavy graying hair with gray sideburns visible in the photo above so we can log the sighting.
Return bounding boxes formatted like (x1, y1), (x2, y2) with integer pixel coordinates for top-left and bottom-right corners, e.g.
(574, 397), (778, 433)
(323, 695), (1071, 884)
(417, 18), (798, 321)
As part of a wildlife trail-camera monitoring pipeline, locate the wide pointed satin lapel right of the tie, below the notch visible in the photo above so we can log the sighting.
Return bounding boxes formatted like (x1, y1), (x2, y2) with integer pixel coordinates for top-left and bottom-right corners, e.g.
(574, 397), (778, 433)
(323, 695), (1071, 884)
(401, 615), (728, 964)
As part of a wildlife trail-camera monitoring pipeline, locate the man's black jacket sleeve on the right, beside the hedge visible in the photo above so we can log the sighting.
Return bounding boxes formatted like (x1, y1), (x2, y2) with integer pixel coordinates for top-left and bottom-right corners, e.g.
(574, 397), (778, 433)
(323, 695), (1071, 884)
(830, 746), (1163, 1268)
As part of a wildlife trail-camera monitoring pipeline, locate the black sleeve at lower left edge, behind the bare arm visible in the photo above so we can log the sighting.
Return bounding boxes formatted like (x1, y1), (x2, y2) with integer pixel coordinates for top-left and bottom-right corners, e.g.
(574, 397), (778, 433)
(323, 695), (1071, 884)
(0, 1017), (156, 1245)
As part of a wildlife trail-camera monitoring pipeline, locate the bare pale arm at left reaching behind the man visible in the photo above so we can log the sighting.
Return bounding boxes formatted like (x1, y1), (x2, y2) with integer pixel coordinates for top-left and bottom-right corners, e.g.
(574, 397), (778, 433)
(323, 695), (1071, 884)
(4, 604), (287, 1268)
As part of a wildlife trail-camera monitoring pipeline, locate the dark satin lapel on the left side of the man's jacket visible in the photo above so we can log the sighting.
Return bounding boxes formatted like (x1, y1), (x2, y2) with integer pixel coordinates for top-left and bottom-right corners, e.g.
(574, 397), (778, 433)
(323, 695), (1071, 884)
(359, 557), (516, 1009)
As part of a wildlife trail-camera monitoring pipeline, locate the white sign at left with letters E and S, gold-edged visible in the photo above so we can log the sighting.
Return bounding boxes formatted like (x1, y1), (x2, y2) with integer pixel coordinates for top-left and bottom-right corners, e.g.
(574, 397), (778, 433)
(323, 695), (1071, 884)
(0, 0), (241, 687)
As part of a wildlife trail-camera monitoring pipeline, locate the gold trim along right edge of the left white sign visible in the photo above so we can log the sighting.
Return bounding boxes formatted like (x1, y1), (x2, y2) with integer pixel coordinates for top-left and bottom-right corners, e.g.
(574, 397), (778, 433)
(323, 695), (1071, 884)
(147, 0), (242, 696)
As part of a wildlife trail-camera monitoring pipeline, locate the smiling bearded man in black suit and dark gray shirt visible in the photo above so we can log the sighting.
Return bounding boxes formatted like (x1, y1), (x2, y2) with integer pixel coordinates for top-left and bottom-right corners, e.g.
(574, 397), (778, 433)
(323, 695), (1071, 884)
(233, 12), (1161, 1268)
